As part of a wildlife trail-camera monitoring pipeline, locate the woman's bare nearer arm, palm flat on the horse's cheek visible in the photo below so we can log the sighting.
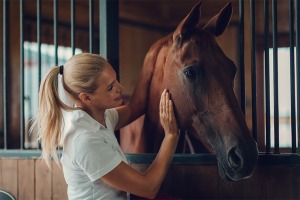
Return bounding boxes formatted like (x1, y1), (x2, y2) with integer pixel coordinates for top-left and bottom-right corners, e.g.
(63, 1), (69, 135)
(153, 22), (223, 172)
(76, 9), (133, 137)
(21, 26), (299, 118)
(101, 90), (179, 198)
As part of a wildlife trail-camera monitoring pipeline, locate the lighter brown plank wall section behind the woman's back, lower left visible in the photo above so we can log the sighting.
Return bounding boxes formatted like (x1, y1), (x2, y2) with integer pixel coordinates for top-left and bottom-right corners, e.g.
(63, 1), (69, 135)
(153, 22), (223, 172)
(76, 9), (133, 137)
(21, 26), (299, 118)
(0, 158), (68, 200)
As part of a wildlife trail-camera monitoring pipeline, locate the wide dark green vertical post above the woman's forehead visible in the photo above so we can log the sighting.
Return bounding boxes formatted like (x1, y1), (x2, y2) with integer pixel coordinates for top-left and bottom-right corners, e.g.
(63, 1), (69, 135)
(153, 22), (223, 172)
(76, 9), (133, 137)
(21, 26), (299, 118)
(99, 0), (119, 79)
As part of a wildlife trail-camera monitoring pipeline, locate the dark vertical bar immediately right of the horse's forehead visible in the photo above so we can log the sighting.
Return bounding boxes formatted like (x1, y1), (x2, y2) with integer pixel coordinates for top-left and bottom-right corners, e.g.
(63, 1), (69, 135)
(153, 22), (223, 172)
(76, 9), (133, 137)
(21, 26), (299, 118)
(239, 0), (246, 115)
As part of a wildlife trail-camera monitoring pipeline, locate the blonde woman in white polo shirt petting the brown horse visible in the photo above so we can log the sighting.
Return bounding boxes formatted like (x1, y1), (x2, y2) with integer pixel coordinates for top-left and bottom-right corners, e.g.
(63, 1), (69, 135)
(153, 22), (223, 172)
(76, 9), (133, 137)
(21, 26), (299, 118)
(34, 53), (179, 199)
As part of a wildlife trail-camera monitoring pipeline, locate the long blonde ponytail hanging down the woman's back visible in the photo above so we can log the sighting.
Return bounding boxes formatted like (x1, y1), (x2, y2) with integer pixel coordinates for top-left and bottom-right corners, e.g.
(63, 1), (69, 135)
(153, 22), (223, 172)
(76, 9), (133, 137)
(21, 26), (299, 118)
(31, 67), (76, 168)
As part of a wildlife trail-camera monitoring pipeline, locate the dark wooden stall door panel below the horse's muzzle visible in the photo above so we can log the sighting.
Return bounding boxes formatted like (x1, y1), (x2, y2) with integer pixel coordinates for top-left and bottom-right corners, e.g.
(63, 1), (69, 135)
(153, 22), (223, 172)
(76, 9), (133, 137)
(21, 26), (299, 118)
(132, 164), (300, 199)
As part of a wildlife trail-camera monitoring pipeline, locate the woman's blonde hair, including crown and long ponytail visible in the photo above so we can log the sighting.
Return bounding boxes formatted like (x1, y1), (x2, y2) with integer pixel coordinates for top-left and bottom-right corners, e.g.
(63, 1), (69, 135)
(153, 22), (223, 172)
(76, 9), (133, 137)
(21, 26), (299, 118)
(31, 53), (107, 168)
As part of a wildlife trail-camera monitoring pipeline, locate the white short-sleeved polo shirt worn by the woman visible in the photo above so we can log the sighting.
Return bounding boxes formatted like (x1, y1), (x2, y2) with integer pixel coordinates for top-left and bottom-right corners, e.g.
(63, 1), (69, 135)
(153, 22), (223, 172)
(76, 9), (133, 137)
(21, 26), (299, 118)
(61, 109), (127, 200)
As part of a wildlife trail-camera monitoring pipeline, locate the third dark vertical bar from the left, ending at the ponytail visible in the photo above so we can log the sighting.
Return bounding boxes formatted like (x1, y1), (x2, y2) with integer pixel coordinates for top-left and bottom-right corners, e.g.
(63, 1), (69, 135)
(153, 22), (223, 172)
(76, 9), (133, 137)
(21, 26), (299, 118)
(36, 0), (42, 85)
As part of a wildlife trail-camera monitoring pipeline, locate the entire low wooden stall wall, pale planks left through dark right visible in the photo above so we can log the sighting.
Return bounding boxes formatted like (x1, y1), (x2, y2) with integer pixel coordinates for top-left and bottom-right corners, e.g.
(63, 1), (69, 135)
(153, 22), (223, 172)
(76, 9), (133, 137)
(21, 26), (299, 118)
(0, 158), (300, 200)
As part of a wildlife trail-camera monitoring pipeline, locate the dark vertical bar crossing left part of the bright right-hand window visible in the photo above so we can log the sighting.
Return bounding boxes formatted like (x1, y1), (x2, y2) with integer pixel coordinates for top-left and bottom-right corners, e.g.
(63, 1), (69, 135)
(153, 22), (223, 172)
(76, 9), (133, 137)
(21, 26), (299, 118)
(272, 0), (279, 153)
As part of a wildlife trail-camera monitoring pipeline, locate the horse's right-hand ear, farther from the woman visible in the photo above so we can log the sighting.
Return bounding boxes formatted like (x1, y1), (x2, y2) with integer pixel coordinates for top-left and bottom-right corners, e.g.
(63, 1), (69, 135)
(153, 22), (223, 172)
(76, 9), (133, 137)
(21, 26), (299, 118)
(203, 3), (232, 36)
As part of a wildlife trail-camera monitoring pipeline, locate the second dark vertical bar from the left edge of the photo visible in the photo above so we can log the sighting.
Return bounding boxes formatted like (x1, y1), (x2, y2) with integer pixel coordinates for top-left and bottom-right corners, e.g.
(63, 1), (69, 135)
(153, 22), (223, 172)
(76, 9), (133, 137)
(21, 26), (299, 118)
(20, 0), (25, 149)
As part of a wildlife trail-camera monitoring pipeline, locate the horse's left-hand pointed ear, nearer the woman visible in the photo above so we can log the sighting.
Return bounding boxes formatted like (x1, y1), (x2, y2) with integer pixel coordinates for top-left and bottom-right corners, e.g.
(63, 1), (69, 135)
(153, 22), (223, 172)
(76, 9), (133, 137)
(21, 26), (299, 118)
(173, 2), (201, 46)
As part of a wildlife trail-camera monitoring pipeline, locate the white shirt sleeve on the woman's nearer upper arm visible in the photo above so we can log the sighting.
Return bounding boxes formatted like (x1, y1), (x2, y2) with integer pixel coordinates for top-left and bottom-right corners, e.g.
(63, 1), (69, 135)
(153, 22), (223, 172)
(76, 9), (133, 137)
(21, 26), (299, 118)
(75, 132), (122, 181)
